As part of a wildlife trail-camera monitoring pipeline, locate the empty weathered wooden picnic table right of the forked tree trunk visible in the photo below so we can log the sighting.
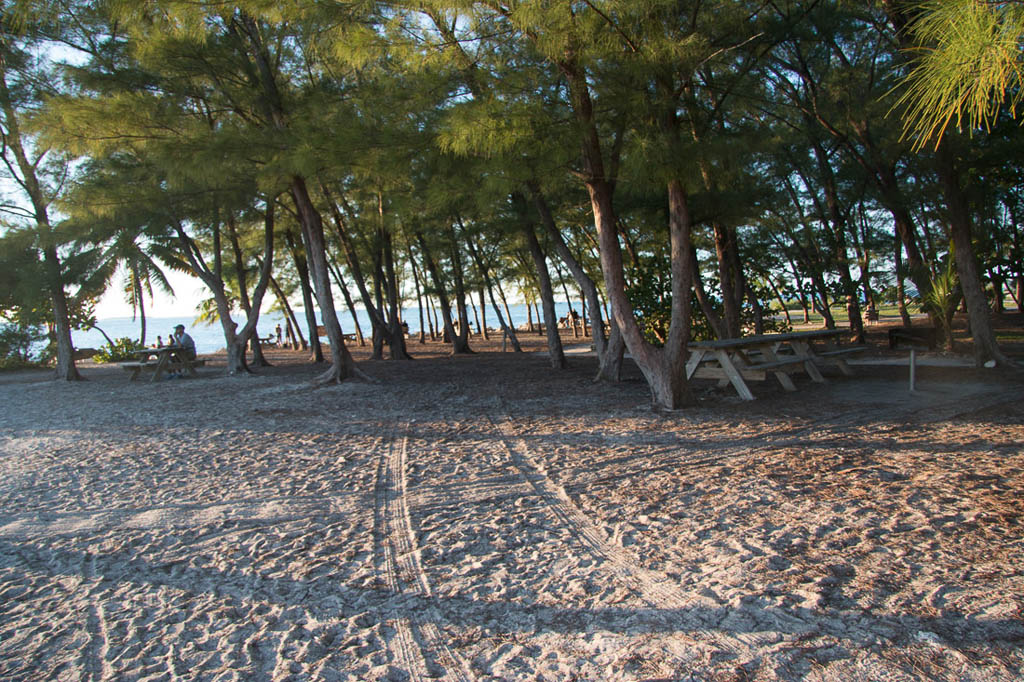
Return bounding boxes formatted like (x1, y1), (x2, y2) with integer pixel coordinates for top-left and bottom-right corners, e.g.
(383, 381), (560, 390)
(686, 329), (864, 400)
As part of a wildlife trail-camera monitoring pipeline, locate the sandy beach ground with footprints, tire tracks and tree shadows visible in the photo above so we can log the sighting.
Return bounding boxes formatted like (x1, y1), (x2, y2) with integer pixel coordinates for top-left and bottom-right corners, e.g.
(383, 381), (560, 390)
(0, 341), (1024, 681)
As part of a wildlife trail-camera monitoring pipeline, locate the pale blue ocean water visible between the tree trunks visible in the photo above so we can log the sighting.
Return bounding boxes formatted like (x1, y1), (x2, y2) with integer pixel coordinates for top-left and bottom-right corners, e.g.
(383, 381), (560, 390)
(72, 300), (593, 353)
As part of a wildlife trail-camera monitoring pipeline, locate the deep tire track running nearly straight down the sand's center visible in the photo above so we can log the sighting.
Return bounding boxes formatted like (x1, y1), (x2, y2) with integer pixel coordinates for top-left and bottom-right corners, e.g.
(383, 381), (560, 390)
(374, 424), (473, 682)
